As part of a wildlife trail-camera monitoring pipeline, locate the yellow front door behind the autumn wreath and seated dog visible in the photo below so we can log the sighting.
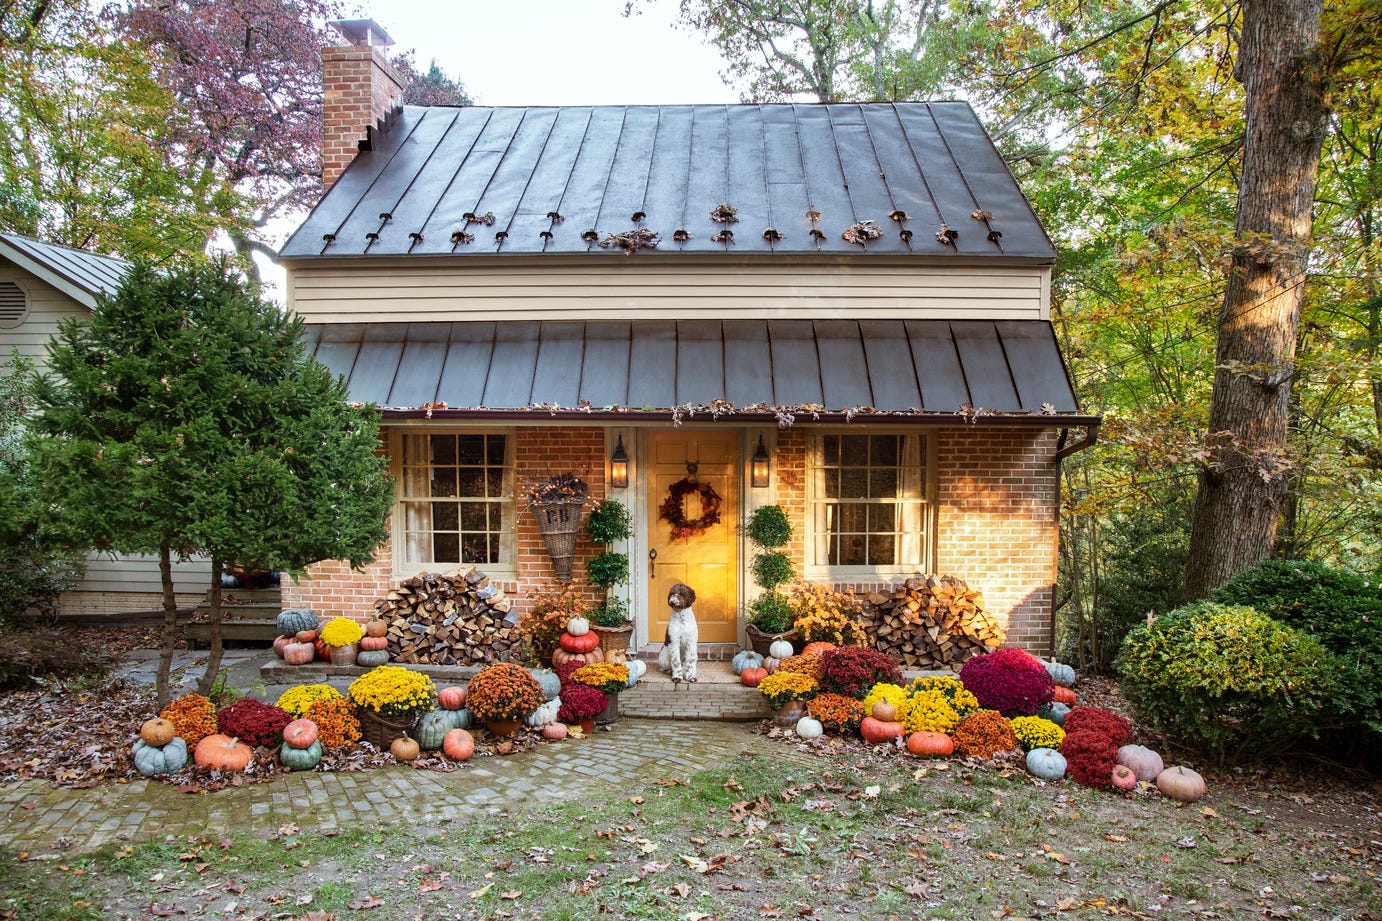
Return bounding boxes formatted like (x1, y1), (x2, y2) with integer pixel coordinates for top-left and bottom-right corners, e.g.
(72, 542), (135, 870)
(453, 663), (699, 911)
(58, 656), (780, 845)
(645, 431), (739, 643)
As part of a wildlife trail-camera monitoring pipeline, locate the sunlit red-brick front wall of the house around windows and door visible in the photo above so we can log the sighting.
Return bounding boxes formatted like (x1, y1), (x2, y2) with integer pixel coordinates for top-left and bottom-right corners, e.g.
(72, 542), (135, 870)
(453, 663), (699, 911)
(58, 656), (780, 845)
(282, 426), (1059, 653)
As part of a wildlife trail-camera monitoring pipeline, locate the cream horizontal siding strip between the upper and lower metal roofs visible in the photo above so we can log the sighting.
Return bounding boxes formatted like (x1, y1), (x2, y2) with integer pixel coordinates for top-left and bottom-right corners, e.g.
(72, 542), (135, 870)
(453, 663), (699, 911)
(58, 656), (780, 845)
(287, 256), (1049, 322)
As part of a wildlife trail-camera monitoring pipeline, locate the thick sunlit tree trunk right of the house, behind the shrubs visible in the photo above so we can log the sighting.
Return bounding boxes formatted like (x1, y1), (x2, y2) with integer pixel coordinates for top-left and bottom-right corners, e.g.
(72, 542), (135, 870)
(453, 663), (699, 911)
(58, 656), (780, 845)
(1183, 0), (1327, 600)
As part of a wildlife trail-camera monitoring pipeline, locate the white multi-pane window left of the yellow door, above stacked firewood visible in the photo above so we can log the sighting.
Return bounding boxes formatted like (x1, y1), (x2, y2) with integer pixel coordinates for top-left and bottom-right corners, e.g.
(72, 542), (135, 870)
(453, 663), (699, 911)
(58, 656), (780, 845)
(402, 433), (514, 566)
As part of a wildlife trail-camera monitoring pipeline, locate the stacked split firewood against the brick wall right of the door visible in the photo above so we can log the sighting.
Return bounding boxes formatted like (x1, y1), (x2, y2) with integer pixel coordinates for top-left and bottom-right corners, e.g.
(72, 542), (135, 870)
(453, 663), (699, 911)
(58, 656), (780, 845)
(864, 575), (1003, 669)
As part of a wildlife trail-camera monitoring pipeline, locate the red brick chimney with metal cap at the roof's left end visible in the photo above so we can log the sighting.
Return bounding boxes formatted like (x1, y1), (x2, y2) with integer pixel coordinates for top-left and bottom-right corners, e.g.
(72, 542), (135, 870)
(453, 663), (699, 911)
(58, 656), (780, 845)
(322, 19), (404, 188)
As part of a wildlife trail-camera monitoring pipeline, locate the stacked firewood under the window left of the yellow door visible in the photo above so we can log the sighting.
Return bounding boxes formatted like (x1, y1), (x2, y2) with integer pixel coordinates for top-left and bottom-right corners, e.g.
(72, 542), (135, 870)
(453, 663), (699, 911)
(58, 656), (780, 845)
(375, 567), (522, 665)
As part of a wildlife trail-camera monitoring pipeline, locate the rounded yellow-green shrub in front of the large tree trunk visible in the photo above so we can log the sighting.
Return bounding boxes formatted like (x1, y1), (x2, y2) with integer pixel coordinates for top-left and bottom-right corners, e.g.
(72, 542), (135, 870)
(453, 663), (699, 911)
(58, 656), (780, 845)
(1118, 602), (1339, 765)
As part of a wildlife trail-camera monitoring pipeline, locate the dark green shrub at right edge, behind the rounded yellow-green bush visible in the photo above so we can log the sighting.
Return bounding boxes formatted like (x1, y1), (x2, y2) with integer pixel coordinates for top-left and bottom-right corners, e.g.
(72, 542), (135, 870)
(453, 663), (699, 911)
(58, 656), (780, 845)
(1212, 560), (1382, 733)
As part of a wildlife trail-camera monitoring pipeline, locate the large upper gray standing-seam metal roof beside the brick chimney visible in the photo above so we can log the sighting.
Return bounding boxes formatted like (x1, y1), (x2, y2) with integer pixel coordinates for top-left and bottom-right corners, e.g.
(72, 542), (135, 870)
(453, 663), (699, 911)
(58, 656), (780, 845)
(281, 102), (1054, 261)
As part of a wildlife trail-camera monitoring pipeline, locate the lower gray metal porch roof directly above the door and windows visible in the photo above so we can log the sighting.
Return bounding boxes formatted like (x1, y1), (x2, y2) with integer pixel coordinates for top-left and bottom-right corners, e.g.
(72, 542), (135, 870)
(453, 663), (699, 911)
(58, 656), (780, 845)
(308, 319), (1079, 414)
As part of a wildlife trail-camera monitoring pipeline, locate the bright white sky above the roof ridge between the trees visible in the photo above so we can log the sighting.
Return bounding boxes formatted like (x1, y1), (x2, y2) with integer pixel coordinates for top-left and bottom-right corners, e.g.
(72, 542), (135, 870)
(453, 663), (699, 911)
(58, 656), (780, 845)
(362, 0), (738, 105)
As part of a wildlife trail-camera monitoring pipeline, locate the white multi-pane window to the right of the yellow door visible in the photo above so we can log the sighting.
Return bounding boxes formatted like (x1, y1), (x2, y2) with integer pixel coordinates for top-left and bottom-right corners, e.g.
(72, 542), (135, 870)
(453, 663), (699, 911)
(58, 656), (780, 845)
(811, 434), (927, 567)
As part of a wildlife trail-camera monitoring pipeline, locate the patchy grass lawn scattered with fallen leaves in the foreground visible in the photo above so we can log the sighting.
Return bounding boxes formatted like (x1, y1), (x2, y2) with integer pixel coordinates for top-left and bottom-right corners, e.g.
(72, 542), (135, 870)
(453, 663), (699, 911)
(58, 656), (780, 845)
(0, 744), (1382, 921)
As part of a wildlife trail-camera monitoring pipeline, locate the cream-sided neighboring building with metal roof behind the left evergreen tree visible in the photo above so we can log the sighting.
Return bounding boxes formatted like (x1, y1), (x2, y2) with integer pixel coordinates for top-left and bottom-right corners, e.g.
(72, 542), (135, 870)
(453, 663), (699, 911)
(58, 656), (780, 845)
(0, 234), (211, 613)
